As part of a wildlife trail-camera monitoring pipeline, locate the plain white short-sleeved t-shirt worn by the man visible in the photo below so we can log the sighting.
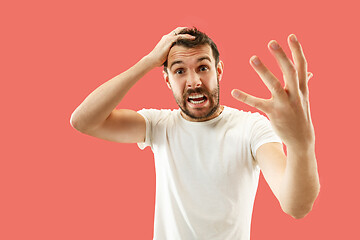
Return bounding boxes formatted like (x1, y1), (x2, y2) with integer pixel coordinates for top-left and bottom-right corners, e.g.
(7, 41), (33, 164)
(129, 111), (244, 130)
(138, 106), (281, 240)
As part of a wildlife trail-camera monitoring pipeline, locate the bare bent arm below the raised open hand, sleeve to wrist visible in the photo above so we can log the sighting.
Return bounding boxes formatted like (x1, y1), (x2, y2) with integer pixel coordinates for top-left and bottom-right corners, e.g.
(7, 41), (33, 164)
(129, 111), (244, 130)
(256, 143), (320, 219)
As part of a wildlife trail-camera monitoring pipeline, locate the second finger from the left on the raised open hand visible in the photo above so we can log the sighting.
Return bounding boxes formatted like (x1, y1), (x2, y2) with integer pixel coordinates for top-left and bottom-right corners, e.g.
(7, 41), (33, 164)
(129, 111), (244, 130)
(250, 56), (284, 96)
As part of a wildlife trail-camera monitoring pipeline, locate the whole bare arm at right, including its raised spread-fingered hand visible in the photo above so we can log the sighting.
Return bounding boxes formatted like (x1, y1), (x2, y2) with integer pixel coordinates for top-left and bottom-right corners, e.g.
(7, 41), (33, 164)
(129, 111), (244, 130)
(232, 35), (320, 218)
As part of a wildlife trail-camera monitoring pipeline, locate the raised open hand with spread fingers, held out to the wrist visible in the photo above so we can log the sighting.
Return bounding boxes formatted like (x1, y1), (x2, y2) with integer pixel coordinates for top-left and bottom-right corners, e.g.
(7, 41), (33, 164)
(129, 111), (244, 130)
(231, 34), (315, 148)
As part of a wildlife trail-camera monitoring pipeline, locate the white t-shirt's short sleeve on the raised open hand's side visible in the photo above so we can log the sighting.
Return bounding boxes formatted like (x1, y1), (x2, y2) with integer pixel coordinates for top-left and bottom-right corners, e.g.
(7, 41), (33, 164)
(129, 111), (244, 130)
(250, 113), (282, 158)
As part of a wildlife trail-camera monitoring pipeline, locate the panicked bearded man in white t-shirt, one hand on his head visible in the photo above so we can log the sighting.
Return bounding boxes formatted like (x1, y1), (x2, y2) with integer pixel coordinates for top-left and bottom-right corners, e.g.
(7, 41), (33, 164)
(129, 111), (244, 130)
(71, 27), (320, 240)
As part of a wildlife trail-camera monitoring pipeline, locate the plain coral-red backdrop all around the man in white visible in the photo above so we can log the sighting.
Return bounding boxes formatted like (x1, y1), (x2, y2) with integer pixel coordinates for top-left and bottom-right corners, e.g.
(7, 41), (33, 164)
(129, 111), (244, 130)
(0, 0), (360, 240)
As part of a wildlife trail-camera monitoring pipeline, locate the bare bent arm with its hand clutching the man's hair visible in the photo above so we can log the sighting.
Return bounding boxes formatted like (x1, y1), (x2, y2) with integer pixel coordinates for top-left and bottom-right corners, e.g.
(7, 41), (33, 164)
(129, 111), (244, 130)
(70, 27), (192, 143)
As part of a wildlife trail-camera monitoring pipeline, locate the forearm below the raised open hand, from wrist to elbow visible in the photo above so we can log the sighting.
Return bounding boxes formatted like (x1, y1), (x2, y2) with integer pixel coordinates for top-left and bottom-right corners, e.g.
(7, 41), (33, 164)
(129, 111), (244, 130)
(280, 145), (320, 218)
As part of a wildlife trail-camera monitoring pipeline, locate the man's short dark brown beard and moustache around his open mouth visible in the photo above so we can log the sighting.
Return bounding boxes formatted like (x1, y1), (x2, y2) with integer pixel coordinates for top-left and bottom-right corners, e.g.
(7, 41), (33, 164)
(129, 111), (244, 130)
(173, 79), (219, 120)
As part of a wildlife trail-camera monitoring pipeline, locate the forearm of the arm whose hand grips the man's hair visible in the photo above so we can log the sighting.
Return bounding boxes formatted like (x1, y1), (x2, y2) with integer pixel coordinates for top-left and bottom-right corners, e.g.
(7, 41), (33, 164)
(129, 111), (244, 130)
(70, 56), (155, 131)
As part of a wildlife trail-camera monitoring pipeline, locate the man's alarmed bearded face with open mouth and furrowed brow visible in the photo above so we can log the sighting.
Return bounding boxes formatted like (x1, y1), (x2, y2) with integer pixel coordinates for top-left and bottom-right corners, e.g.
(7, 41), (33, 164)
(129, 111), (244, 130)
(164, 44), (223, 121)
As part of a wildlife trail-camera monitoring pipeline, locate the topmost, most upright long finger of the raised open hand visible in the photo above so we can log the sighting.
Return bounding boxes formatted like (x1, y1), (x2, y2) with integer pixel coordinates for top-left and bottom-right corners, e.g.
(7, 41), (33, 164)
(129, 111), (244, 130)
(288, 34), (308, 92)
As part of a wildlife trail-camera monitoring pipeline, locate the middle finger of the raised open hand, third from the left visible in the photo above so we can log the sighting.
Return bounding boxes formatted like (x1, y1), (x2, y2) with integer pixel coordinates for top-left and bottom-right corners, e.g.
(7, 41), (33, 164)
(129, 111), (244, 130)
(268, 40), (299, 93)
